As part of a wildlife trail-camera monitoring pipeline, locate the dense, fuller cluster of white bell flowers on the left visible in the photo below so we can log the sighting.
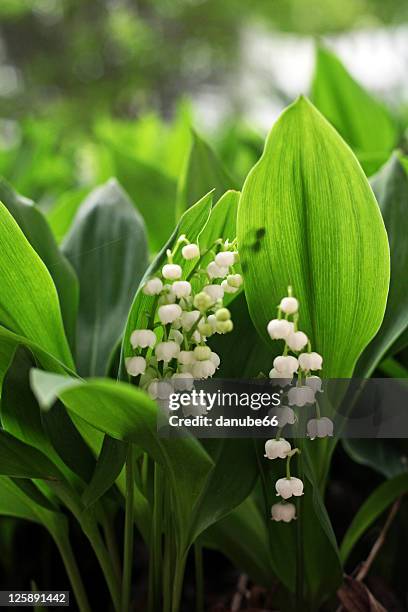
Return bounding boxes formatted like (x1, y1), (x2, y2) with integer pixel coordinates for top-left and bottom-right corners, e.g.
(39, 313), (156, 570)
(126, 235), (242, 400)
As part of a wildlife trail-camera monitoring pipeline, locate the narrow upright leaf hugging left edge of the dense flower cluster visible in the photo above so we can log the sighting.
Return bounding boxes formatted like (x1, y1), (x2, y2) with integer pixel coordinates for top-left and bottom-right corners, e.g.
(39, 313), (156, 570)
(120, 193), (212, 372)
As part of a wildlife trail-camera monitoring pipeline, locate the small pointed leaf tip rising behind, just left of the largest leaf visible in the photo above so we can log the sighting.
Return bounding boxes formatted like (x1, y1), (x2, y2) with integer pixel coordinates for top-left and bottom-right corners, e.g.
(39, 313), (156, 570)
(177, 131), (237, 216)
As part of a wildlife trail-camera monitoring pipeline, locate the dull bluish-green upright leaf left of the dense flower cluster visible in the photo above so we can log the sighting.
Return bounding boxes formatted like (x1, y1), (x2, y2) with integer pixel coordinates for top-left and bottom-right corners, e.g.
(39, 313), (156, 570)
(63, 180), (147, 376)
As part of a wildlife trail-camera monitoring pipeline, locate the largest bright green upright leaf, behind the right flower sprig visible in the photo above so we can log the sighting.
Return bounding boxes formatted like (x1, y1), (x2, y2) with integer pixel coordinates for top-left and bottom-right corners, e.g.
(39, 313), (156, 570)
(238, 98), (389, 378)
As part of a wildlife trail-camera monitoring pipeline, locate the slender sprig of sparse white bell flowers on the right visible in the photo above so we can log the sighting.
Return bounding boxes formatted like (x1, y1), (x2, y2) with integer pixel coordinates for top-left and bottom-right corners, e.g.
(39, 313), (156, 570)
(265, 287), (333, 523)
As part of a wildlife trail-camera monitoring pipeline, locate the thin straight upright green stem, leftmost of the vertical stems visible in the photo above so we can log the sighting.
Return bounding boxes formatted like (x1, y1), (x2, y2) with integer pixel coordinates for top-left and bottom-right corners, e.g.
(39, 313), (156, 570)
(121, 444), (135, 612)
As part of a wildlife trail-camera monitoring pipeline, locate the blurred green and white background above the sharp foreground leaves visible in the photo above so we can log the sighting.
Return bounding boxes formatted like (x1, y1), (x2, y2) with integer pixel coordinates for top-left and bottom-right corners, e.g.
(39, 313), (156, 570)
(0, 0), (408, 249)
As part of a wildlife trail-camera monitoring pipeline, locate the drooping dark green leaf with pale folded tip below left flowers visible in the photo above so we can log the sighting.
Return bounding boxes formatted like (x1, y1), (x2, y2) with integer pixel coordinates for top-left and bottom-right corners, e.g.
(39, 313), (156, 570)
(31, 370), (214, 548)
